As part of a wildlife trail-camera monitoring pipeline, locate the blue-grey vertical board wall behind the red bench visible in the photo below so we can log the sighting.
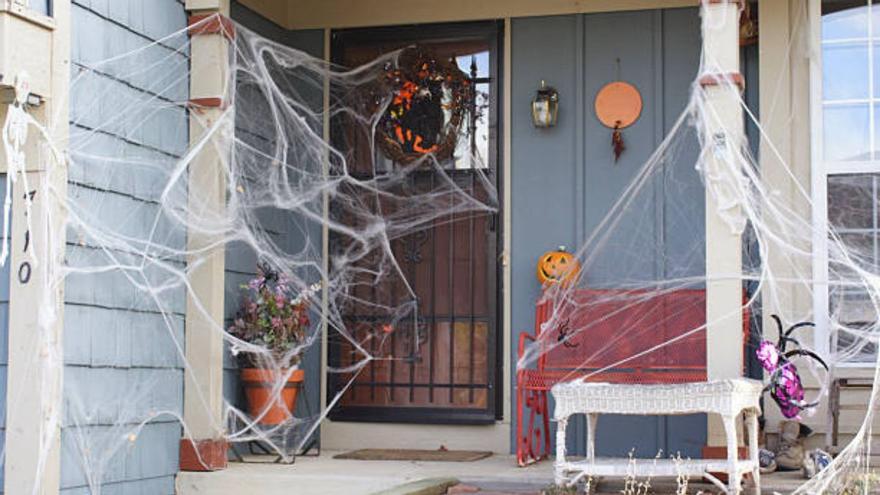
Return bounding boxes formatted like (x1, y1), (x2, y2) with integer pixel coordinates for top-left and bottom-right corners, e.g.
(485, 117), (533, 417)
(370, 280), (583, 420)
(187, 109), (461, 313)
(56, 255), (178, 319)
(510, 8), (705, 457)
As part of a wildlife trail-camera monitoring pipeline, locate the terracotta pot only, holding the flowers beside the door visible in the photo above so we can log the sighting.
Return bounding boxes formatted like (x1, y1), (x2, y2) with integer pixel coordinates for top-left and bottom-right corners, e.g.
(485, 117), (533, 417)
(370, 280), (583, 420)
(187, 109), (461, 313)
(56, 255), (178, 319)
(241, 368), (306, 425)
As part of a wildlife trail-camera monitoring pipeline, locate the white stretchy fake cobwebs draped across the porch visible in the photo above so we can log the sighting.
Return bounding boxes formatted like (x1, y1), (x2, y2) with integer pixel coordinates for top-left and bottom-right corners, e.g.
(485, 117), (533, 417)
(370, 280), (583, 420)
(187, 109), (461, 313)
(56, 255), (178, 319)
(0, 1), (880, 493)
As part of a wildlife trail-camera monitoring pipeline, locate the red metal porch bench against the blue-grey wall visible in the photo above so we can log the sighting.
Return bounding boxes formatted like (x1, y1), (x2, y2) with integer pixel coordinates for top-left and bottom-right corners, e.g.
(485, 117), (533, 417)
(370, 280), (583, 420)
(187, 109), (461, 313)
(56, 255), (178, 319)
(516, 289), (748, 466)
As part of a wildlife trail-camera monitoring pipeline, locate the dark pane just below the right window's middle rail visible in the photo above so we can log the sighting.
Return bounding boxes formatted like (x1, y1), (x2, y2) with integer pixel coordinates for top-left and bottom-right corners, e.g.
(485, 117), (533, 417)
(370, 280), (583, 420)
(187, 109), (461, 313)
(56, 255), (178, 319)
(828, 174), (875, 229)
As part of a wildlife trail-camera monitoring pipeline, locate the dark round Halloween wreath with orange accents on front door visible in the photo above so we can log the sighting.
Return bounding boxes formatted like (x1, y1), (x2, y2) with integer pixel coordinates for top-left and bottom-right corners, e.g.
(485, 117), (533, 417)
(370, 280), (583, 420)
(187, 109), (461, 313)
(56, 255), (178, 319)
(375, 47), (474, 165)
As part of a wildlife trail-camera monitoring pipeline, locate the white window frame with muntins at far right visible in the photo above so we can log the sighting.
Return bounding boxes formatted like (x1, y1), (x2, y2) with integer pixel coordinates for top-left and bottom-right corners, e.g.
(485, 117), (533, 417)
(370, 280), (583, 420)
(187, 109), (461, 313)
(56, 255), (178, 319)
(807, 0), (880, 369)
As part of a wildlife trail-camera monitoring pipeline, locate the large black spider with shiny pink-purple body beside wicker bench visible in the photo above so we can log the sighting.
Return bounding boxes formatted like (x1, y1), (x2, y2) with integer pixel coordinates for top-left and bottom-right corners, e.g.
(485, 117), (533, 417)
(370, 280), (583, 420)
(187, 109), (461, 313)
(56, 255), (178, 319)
(756, 315), (828, 419)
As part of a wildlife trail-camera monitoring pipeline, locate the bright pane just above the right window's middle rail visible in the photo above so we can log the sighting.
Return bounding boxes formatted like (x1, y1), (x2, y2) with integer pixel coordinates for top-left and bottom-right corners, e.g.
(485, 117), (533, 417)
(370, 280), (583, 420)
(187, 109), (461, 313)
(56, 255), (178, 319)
(823, 105), (871, 161)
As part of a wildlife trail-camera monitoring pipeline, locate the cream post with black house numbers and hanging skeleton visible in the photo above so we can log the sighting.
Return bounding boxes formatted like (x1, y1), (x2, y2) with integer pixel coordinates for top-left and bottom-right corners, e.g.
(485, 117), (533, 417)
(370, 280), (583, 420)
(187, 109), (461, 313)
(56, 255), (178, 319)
(0, 0), (70, 495)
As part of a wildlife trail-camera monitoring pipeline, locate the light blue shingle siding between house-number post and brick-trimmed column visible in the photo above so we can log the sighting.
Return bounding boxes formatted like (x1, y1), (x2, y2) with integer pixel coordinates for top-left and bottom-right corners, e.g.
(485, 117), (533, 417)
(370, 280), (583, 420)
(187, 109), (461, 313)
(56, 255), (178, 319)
(61, 0), (189, 495)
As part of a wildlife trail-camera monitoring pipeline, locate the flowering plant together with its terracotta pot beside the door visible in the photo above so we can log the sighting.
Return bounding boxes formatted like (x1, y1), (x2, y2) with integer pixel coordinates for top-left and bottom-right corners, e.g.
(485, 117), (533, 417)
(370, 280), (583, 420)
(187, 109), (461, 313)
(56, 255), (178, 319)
(229, 264), (320, 425)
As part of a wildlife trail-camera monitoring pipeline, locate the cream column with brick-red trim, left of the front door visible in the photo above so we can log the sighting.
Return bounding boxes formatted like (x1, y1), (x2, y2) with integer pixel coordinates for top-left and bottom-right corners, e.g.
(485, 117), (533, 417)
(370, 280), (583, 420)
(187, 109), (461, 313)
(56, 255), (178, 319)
(180, 0), (234, 471)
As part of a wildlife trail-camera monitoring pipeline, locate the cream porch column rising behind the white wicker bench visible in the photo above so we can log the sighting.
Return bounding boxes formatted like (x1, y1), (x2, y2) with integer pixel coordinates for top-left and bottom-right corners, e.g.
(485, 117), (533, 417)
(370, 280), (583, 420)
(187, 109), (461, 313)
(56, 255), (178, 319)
(700, 0), (744, 450)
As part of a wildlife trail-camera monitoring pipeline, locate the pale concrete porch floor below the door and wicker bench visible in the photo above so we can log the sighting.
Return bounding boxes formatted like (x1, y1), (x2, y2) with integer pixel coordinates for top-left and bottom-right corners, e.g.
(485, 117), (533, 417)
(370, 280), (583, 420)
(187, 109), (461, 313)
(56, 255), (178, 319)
(177, 450), (803, 495)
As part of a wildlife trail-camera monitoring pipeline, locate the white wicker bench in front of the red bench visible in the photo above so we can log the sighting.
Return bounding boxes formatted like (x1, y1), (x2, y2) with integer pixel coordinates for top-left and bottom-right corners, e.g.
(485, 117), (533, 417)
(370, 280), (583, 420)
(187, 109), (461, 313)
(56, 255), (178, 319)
(552, 378), (763, 495)
